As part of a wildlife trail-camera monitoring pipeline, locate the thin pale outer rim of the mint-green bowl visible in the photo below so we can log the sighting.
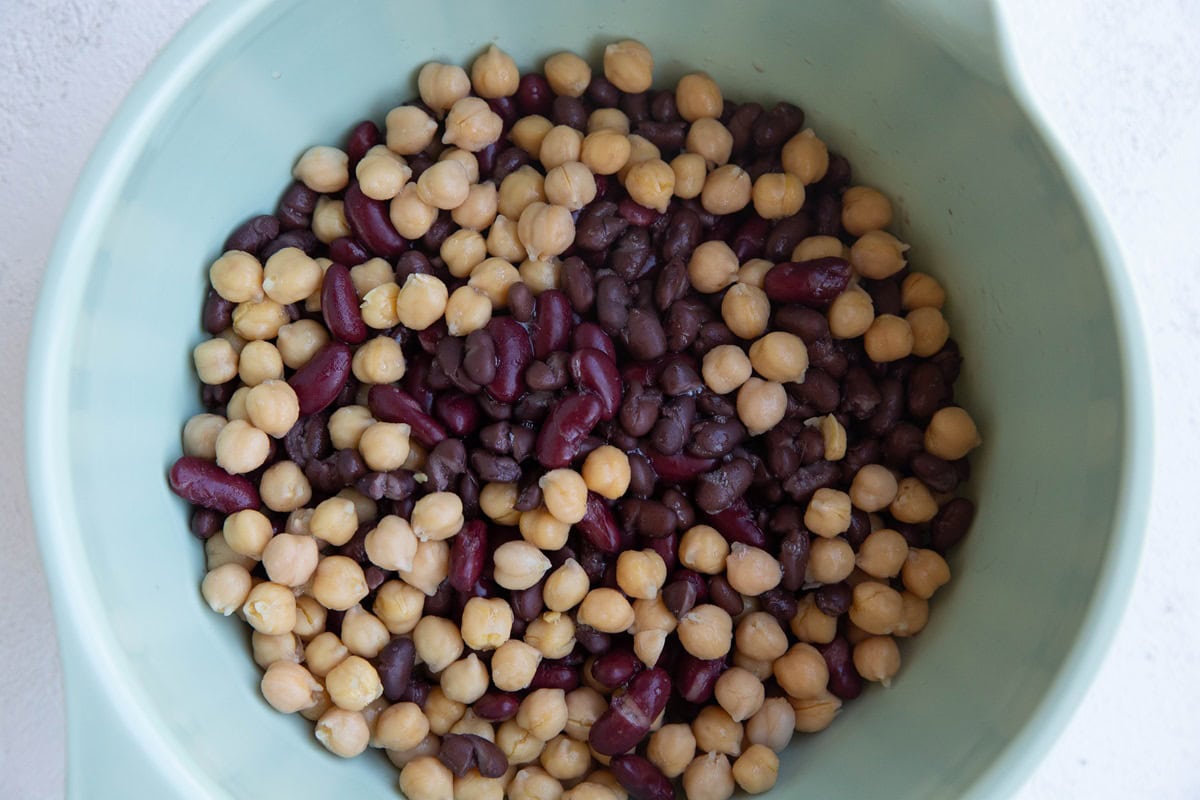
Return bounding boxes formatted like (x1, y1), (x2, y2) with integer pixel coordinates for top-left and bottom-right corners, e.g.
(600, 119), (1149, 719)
(24, 0), (1153, 798)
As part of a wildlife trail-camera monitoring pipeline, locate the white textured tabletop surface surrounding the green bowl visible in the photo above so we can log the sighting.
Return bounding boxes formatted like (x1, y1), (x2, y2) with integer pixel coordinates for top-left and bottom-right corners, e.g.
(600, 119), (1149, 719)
(0, 0), (1200, 800)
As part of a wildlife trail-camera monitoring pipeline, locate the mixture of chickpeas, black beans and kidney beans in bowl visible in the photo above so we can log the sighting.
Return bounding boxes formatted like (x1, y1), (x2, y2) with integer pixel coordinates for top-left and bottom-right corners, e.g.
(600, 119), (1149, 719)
(170, 41), (980, 800)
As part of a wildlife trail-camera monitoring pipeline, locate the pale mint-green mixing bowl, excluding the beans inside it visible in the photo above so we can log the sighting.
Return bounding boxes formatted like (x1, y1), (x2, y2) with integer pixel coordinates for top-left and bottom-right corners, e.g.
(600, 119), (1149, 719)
(26, 0), (1151, 800)
